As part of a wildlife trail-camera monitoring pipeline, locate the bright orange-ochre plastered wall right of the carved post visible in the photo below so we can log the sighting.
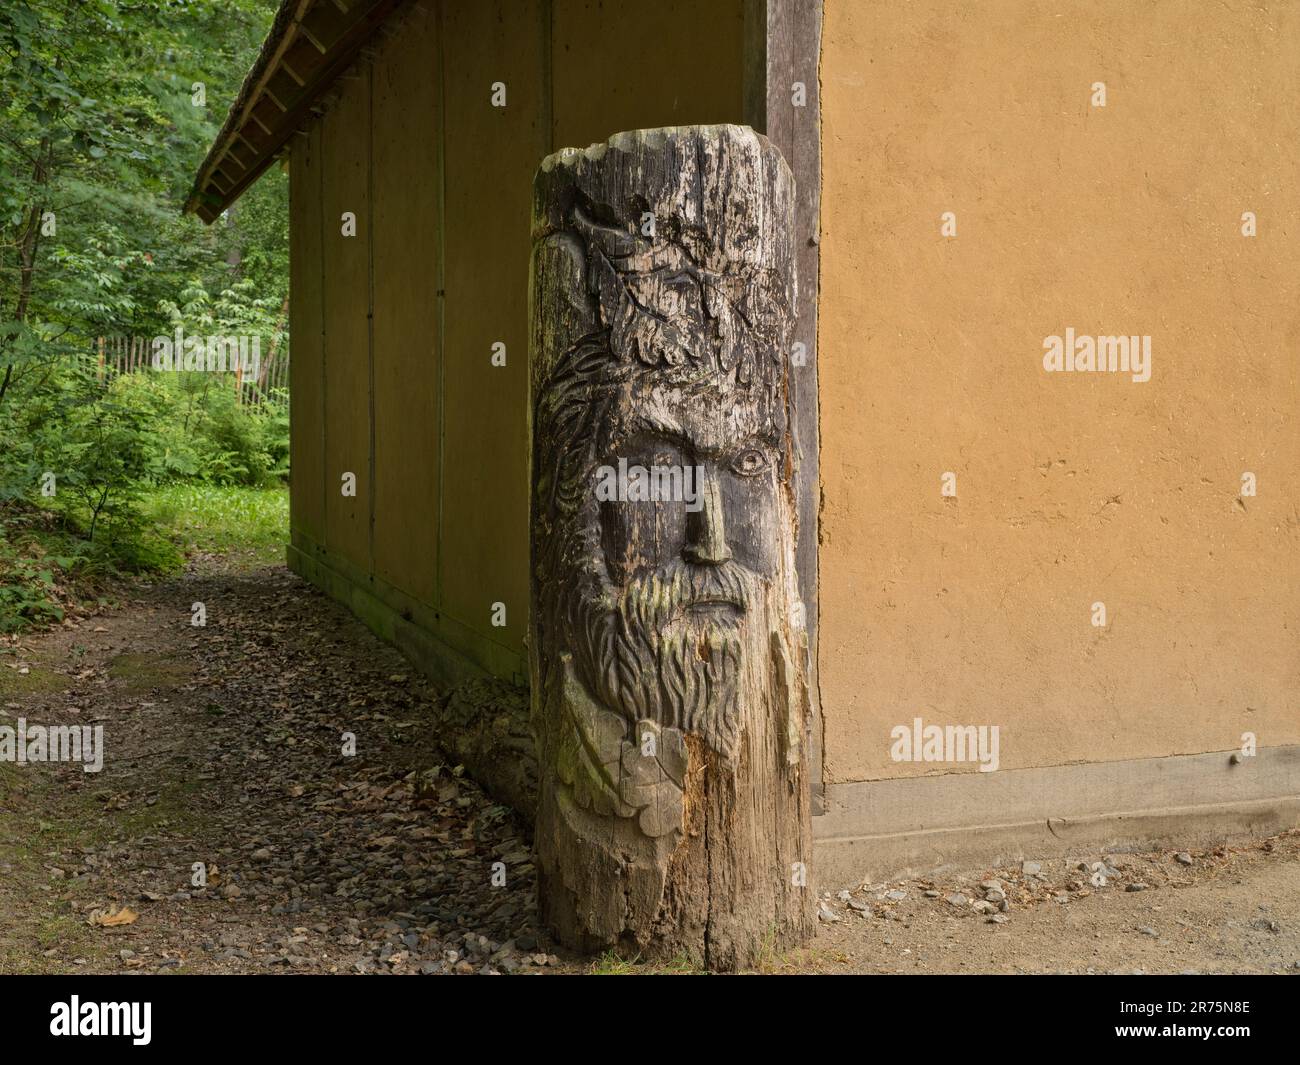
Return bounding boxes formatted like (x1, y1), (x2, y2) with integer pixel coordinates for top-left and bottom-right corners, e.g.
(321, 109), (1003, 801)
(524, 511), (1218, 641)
(818, 0), (1300, 782)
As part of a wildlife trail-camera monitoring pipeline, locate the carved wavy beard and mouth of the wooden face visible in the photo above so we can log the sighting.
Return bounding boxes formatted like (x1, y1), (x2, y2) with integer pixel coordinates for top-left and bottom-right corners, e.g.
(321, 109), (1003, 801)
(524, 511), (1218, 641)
(580, 560), (767, 758)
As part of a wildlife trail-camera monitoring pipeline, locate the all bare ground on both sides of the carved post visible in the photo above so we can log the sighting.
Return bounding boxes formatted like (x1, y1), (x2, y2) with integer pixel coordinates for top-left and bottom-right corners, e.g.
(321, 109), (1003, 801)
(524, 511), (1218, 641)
(0, 559), (1300, 974)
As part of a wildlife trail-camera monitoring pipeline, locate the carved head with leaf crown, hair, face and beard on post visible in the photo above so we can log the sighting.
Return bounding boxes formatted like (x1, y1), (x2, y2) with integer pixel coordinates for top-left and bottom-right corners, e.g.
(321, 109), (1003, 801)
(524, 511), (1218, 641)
(536, 152), (794, 757)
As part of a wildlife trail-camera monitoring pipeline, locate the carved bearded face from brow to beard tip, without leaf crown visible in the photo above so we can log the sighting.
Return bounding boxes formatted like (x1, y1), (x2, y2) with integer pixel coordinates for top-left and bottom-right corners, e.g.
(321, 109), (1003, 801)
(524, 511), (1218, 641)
(573, 358), (787, 754)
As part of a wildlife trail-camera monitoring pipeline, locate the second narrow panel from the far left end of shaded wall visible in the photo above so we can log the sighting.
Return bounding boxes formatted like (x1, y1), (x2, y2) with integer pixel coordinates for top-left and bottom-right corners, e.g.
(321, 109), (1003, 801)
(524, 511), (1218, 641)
(321, 66), (373, 570)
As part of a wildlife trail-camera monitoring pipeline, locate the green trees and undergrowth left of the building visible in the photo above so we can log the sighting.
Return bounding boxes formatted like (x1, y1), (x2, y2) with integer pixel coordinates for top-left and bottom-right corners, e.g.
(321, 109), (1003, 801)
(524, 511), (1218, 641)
(0, 0), (289, 629)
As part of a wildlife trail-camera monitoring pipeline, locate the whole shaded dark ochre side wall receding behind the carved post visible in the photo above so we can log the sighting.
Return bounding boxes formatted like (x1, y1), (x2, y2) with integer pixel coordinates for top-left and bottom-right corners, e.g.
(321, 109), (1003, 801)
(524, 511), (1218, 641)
(290, 0), (744, 680)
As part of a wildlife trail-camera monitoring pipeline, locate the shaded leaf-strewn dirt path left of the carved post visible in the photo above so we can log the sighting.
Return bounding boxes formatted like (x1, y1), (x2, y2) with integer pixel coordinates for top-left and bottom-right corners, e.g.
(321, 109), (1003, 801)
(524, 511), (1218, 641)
(0, 567), (551, 973)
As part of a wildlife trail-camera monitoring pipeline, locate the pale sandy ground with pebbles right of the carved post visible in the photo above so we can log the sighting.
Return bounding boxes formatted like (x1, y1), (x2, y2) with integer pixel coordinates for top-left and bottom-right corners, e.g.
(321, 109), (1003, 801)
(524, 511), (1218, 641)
(806, 832), (1300, 975)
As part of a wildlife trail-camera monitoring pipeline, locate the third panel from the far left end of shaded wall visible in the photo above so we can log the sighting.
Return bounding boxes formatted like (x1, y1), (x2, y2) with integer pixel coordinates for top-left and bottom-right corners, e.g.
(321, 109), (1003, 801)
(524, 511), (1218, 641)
(373, 8), (441, 605)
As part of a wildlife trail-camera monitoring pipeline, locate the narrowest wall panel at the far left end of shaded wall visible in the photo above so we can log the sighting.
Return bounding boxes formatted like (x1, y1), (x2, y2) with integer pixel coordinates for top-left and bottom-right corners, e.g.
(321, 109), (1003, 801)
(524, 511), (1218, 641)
(289, 122), (325, 544)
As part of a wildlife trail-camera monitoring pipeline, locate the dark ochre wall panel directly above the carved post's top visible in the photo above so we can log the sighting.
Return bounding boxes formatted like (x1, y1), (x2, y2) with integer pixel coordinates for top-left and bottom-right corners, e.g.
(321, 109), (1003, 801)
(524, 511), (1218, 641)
(551, 0), (745, 148)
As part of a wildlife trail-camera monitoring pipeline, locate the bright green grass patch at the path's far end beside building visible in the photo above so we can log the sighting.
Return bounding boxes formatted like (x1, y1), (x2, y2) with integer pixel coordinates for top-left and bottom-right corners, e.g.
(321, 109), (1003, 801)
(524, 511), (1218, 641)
(144, 484), (289, 563)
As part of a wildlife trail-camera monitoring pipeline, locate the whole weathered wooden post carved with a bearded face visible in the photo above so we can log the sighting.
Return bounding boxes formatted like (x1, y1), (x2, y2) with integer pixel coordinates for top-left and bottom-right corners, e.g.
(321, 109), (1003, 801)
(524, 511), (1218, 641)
(529, 126), (814, 970)
